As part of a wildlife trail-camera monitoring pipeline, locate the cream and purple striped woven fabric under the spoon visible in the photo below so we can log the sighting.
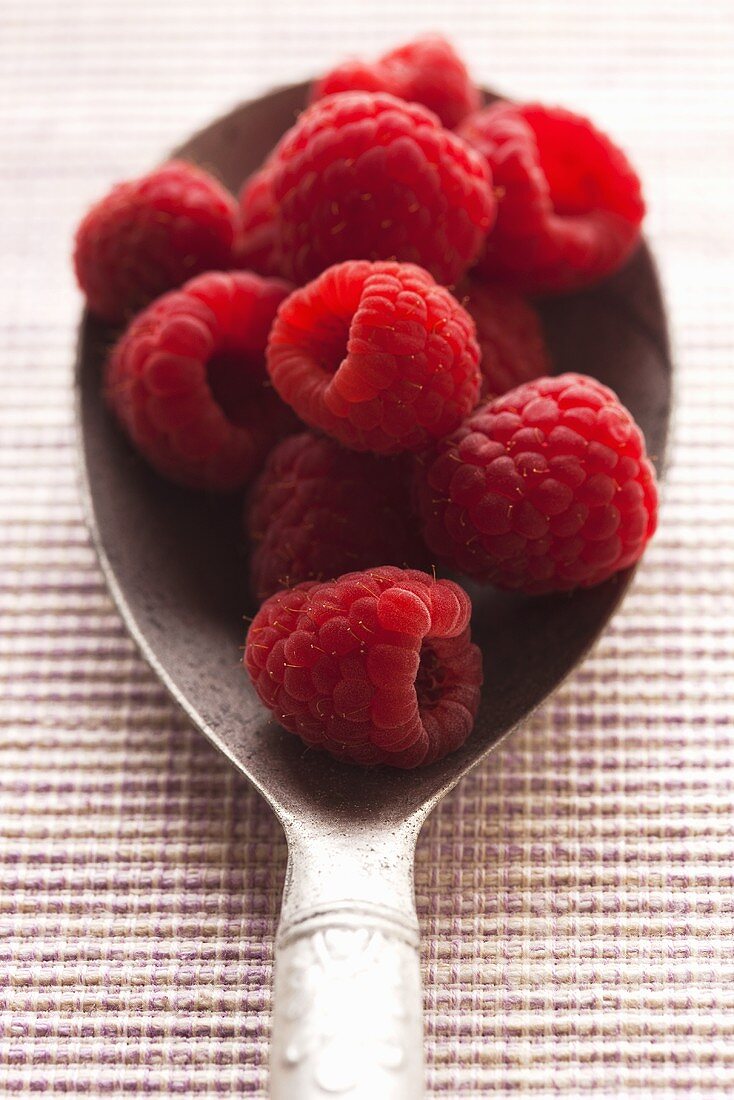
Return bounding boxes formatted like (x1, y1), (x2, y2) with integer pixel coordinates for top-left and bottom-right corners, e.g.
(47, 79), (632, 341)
(0, 0), (734, 1100)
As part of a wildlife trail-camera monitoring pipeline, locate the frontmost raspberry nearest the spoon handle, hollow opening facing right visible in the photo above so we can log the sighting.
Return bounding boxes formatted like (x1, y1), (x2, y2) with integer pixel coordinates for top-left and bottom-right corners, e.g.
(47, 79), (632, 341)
(244, 565), (482, 768)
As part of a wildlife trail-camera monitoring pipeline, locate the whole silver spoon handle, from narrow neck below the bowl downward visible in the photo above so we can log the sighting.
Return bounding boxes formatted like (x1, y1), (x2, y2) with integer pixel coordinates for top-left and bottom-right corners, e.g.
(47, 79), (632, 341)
(271, 836), (424, 1100)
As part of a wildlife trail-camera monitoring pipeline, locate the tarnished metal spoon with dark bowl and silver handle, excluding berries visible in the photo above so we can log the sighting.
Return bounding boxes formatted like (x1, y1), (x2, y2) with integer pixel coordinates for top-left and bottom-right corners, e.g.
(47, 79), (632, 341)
(77, 85), (671, 1100)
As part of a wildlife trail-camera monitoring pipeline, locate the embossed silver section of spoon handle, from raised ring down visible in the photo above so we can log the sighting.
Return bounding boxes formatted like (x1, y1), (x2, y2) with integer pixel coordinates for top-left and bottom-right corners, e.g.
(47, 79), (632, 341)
(271, 910), (423, 1100)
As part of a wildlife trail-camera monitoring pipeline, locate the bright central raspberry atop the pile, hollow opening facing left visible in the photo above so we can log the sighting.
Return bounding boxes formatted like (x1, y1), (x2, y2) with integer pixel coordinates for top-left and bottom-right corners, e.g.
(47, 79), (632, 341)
(267, 259), (480, 454)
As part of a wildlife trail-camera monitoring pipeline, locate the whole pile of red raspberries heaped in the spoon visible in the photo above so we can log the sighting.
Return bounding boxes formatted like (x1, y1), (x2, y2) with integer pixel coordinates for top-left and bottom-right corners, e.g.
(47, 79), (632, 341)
(74, 37), (657, 768)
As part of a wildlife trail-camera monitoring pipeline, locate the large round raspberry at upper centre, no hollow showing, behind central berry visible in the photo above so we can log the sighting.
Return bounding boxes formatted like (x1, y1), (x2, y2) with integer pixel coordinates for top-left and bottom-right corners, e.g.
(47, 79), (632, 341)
(241, 91), (495, 284)
